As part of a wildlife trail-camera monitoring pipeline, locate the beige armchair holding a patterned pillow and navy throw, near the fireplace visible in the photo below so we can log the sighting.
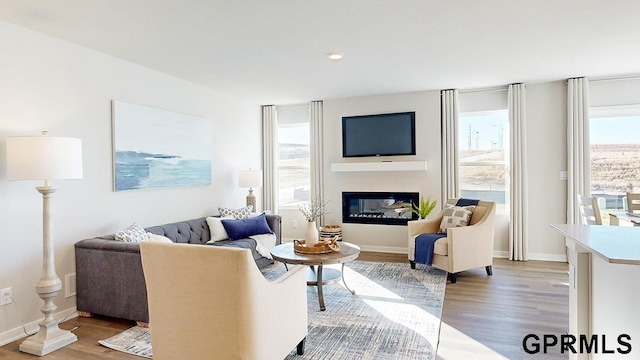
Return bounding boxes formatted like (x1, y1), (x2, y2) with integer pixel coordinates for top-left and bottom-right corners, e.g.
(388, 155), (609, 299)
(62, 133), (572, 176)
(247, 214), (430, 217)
(407, 199), (496, 283)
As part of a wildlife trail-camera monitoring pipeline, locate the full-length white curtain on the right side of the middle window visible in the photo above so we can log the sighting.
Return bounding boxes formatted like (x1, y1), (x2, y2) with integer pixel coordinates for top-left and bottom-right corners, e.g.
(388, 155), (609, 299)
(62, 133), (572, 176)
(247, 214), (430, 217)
(507, 84), (529, 261)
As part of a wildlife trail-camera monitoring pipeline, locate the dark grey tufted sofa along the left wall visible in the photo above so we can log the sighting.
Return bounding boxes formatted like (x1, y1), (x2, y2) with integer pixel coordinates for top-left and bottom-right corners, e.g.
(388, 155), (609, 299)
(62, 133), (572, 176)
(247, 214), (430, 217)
(75, 214), (282, 323)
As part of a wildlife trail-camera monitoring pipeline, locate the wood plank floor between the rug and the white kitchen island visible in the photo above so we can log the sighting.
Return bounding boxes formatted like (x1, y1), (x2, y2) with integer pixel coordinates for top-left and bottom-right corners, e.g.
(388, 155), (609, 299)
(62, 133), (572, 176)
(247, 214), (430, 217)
(360, 253), (569, 360)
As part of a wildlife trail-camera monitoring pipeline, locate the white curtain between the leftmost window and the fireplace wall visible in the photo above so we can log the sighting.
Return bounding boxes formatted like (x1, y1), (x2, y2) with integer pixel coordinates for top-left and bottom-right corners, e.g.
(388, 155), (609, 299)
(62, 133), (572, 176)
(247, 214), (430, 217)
(309, 101), (325, 226)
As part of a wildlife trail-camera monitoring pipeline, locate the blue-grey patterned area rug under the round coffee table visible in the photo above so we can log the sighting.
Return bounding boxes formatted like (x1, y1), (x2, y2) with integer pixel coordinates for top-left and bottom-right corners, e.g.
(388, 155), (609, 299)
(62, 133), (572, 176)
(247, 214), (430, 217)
(100, 260), (447, 360)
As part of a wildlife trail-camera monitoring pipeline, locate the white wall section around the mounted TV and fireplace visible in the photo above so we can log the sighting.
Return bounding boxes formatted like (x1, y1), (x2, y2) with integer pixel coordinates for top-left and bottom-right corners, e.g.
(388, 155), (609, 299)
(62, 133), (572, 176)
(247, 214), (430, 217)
(323, 91), (440, 253)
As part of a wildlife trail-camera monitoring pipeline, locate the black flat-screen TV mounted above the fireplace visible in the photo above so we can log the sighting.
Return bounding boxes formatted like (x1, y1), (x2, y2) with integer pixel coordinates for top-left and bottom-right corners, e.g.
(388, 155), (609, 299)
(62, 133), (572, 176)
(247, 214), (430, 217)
(342, 112), (416, 157)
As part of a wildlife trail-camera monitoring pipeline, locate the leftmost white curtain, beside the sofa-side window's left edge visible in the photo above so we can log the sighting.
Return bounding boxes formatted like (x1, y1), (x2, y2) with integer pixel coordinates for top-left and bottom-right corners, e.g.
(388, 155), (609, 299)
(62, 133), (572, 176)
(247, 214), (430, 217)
(262, 105), (278, 214)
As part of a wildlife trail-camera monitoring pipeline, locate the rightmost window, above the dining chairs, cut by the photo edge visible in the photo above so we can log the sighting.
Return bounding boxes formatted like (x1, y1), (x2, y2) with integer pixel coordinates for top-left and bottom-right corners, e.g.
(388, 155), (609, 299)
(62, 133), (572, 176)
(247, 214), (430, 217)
(589, 105), (640, 224)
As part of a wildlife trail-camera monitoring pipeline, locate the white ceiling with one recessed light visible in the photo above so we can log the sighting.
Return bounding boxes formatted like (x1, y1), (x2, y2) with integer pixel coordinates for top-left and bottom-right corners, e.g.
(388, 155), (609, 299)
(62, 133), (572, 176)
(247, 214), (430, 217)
(0, 0), (640, 104)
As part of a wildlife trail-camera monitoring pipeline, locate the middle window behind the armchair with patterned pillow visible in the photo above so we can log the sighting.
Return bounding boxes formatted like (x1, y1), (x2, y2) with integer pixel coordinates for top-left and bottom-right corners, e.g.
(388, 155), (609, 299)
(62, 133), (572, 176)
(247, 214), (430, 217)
(458, 110), (509, 212)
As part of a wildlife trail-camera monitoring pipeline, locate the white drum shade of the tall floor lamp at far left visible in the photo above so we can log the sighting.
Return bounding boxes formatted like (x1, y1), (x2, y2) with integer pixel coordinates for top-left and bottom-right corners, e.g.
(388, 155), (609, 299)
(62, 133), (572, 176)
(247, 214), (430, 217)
(7, 135), (82, 180)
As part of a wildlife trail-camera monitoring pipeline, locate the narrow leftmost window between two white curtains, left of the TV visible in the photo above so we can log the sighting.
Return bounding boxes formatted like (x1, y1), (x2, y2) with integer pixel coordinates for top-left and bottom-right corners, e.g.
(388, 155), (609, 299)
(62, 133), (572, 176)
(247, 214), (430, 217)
(277, 105), (311, 207)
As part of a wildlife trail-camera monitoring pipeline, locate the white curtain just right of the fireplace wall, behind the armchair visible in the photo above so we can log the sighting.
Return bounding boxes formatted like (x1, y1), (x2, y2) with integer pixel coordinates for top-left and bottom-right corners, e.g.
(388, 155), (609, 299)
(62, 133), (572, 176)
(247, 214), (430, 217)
(440, 90), (459, 206)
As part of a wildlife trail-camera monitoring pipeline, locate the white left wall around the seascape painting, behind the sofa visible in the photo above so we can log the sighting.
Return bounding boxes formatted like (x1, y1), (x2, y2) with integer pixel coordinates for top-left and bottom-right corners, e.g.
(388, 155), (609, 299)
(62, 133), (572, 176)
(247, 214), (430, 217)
(0, 22), (261, 344)
